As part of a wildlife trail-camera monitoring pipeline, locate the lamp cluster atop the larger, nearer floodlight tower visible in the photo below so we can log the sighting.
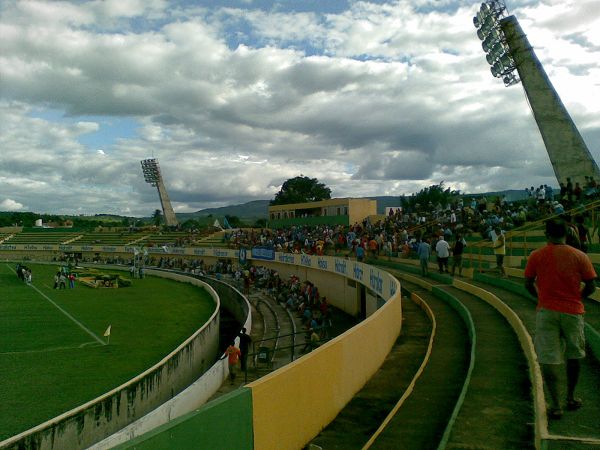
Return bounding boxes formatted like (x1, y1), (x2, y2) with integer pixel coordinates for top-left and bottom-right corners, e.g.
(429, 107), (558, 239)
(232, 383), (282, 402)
(473, 0), (519, 86)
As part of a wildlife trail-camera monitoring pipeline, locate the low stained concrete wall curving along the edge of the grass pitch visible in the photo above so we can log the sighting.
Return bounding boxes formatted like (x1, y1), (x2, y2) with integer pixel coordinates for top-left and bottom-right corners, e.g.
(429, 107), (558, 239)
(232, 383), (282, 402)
(0, 267), (219, 450)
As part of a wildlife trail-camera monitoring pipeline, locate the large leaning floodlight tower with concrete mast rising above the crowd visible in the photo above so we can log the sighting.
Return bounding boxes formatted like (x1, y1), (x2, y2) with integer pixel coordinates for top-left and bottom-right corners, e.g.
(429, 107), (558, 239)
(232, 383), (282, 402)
(473, 0), (600, 186)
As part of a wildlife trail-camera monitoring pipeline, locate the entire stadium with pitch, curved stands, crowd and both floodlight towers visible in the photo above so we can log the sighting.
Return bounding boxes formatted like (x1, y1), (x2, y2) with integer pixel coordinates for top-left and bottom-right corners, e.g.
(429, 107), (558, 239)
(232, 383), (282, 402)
(0, 0), (600, 450)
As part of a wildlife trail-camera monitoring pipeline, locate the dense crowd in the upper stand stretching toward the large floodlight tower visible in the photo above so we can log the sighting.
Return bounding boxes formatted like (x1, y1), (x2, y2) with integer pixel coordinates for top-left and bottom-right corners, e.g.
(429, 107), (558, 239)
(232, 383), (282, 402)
(224, 181), (599, 260)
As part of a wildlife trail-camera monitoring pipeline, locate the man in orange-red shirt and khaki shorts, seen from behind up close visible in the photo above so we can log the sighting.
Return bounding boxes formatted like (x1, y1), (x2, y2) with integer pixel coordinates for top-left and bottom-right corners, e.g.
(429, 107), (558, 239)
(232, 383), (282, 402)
(525, 218), (596, 419)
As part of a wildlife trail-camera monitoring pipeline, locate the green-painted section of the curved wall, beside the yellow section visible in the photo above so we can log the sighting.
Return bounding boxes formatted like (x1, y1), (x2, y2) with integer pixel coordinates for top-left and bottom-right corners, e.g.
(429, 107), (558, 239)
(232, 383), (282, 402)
(115, 388), (253, 450)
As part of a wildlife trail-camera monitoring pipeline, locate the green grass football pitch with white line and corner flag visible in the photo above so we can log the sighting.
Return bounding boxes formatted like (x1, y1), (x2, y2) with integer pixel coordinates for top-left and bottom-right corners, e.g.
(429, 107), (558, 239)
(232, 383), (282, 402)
(0, 262), (215, 441)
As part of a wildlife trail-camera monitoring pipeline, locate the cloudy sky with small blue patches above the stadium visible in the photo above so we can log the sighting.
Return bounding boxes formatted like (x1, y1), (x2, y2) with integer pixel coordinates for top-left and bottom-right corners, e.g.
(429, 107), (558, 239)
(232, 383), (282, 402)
(0, 0), (600, 216)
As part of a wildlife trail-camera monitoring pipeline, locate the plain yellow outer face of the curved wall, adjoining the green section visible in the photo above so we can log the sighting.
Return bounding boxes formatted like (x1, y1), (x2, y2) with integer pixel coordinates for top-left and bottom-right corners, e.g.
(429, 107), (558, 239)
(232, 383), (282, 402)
(247, 289), (402, 450)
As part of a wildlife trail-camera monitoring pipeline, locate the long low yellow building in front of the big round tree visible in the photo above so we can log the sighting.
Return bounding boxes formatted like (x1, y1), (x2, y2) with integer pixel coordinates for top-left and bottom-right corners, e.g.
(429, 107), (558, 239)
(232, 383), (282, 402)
(268, 198), (377, 228)
